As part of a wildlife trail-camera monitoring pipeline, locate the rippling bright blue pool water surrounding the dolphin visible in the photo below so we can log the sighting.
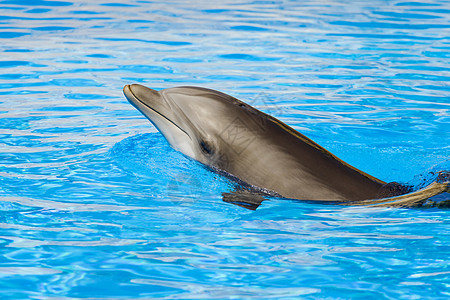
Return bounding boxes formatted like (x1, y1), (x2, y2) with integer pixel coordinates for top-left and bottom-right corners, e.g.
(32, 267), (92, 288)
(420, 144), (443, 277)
(0, 0), (450, 299)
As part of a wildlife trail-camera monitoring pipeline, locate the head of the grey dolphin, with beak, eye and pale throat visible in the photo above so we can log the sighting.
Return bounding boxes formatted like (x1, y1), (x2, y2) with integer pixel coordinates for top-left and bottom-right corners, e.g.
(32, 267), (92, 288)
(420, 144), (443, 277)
(124, 84), (265, 170)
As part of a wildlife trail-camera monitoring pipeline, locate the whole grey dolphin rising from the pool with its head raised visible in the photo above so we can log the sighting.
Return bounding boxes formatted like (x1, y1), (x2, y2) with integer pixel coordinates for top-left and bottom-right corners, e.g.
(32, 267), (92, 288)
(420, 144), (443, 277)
(123, 84), (450, 209)
